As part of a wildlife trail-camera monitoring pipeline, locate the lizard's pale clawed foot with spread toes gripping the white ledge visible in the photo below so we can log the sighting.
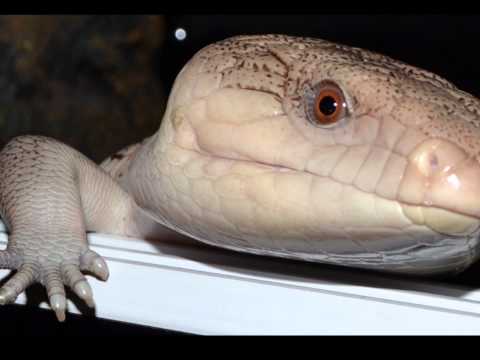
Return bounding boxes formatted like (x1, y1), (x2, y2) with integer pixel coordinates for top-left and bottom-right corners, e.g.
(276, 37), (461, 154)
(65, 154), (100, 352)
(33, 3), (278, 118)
(0, 249), (109, 321)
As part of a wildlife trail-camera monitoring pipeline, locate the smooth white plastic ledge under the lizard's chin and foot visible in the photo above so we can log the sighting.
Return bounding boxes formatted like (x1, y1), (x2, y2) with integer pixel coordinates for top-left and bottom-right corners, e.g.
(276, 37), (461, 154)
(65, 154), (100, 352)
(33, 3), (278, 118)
(0, 224), (480, 335)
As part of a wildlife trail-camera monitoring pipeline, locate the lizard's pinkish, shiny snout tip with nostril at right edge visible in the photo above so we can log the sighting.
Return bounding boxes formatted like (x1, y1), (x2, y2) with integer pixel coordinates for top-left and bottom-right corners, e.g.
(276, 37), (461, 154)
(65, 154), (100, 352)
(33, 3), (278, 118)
(398, 139), (480, 235)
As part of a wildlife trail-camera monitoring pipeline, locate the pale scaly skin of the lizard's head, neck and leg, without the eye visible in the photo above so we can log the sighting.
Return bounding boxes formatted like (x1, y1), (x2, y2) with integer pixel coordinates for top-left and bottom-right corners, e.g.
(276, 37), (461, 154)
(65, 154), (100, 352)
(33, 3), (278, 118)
(0, 35), (480, 320)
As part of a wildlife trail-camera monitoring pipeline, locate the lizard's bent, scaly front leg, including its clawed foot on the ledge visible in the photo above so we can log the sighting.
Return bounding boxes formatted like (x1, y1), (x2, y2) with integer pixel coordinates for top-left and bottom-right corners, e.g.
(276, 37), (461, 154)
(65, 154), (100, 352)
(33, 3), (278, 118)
(0, 136), (137, 321)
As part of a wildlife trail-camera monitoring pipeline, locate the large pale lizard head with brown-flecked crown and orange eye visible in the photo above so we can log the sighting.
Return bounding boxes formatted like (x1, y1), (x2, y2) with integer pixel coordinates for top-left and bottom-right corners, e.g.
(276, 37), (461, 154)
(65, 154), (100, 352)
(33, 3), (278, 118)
(145, 35), (480, 274)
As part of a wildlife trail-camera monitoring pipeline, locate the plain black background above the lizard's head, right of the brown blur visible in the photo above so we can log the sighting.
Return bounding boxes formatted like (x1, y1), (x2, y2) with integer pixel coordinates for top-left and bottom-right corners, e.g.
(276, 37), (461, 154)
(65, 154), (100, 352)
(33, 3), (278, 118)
(159, 14), (480, 96)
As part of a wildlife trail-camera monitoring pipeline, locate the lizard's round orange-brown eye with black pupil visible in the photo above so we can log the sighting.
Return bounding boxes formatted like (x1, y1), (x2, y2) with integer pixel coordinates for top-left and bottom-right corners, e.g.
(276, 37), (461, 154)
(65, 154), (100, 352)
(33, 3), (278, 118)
(306, 81), (348, 126)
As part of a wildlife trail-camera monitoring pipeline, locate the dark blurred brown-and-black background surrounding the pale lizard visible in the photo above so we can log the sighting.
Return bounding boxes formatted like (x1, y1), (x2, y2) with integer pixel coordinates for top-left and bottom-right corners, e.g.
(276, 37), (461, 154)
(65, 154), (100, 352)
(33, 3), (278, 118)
(0, 14), (480, 335)
